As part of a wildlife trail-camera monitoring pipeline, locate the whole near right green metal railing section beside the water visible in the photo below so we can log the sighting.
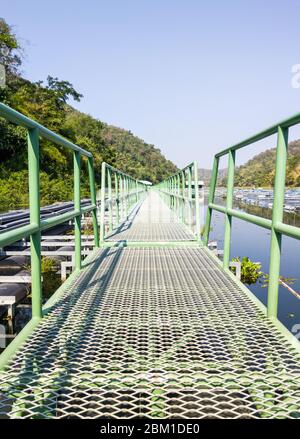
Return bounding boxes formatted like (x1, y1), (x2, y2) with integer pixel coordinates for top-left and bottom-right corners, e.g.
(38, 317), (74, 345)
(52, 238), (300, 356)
(204, 114), (300, 318)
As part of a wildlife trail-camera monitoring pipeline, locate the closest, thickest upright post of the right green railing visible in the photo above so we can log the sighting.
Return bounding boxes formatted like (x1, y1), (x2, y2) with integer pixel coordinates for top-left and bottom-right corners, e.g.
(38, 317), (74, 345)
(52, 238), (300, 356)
(267, 126), (288, 318)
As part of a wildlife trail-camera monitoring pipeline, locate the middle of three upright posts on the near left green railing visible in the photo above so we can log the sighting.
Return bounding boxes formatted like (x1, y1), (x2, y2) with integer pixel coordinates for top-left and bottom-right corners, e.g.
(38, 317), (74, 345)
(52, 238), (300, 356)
(73, 151), (81, 270)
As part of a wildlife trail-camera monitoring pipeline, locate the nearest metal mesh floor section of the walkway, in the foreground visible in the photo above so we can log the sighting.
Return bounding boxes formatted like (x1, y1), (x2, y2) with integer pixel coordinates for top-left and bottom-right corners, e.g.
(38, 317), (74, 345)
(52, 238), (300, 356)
(0, 247), (300, 418)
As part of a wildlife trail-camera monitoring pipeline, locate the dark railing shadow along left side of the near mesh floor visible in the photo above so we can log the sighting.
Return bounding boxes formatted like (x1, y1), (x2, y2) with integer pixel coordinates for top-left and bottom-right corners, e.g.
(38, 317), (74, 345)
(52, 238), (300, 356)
(0, 247), (123, 418)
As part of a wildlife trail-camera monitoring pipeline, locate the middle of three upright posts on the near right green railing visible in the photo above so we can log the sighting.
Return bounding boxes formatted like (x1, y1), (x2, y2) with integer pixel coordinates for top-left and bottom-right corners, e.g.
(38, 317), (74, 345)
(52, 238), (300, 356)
(223, 150), (235, 268)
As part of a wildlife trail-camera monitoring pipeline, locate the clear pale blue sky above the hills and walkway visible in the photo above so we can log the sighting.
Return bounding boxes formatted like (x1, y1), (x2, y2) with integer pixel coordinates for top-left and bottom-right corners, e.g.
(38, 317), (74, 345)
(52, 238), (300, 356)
(0, 0), (300, 167)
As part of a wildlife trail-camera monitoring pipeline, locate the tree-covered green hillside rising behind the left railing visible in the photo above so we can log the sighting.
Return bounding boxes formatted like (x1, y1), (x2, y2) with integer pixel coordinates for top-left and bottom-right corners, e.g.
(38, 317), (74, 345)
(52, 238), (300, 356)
(0, 19), (176, 210)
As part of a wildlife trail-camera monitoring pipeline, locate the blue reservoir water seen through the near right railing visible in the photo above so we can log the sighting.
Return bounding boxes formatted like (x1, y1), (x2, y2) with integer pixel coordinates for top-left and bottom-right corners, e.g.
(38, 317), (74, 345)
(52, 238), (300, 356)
(205, 198), (300, 331)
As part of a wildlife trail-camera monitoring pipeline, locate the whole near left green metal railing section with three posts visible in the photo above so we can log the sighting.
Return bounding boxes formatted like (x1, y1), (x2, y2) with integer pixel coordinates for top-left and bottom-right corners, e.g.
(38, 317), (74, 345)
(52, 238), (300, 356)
(0, 103), (99, 319)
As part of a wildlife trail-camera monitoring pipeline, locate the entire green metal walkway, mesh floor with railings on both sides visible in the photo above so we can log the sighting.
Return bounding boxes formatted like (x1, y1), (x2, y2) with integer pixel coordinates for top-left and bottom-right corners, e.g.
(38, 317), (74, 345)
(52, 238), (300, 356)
(0, 102), (300, 418)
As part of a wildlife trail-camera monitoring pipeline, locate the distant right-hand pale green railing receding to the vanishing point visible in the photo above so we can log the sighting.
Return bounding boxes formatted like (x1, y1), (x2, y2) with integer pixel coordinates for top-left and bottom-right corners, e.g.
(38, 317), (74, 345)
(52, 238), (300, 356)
(156, 161), (201, 241)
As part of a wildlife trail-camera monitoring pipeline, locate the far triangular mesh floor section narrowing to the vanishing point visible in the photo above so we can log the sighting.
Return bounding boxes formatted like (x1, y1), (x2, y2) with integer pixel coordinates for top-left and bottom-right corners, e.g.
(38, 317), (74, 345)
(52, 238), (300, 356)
(106, 190), (195, 242)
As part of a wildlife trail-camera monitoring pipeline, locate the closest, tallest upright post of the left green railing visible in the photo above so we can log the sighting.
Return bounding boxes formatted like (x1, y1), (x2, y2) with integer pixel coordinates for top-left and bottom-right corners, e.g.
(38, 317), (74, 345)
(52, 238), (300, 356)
(27, 128), (42, 318)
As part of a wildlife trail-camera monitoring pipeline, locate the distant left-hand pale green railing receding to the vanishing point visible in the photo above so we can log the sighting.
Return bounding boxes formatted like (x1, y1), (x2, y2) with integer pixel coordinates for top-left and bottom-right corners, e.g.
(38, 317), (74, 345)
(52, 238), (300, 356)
(100, 162), (147, 243)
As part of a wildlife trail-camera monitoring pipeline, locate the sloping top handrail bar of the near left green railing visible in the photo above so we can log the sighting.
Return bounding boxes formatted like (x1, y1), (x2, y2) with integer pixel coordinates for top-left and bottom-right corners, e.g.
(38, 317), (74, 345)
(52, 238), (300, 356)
(0, 103), (93, 157)
